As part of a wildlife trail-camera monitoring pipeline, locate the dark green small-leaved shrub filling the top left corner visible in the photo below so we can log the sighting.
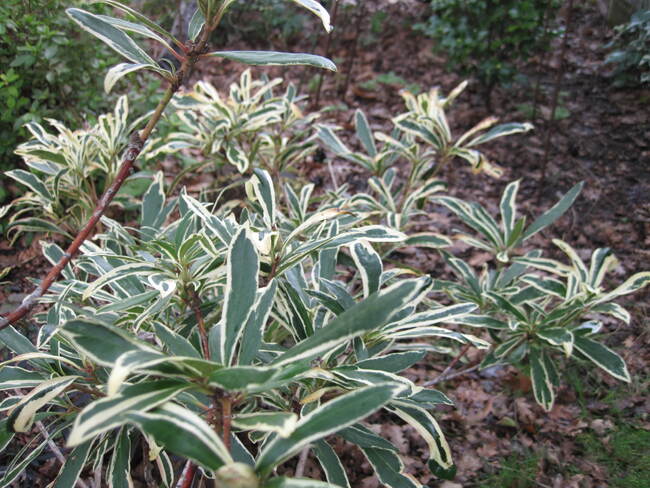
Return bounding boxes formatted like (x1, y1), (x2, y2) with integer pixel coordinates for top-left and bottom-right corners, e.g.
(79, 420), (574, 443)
(0, 0), (116, 201)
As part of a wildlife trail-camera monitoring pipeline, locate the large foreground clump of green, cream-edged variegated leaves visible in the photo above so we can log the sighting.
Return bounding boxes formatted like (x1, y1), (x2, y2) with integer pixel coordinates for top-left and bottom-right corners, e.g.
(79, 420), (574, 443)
(0, 170), (487, 488)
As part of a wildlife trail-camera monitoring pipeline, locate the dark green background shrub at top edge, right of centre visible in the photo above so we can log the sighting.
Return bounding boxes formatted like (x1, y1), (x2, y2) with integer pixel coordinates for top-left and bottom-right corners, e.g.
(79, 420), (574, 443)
(416, 0), (559, 98)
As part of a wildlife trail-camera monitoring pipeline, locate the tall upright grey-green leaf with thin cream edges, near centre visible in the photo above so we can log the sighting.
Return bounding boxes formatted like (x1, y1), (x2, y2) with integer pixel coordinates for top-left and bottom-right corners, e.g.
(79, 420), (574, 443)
(221, 228), (259, 365)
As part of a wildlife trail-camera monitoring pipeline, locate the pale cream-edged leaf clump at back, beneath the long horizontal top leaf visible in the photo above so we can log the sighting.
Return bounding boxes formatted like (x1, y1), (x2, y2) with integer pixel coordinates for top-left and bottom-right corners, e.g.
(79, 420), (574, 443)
(156, 70), (318, 178)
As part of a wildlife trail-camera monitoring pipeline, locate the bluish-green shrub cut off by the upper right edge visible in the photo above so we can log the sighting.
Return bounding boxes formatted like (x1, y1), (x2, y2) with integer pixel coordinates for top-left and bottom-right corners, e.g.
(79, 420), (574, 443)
(606, 10), (650, 84)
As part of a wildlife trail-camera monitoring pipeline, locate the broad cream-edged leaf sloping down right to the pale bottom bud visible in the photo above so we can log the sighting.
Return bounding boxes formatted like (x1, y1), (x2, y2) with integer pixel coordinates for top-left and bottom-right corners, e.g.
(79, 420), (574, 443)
(126, 403), (233, 471)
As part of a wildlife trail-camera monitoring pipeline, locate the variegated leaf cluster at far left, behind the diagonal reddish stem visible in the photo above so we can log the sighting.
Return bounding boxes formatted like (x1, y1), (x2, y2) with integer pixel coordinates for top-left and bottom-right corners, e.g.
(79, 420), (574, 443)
(5, 96), (147, 239)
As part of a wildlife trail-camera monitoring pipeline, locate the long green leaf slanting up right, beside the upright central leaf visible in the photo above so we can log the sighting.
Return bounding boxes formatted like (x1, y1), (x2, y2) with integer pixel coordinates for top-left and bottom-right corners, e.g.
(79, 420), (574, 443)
(274, 278), (431, 365)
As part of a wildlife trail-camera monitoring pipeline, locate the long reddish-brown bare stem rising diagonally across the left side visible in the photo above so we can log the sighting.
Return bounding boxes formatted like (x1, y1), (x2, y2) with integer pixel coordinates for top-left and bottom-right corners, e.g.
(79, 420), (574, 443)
(0, 21), (216, 330)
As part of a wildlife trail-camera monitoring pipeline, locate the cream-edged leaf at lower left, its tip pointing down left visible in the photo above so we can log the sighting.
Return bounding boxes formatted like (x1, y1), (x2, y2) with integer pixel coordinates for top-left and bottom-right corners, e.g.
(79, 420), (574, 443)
(68, 380), (189, 446)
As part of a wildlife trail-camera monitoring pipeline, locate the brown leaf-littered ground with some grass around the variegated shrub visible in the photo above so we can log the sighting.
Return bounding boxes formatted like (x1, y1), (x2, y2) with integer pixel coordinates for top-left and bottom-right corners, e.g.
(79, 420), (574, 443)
(0, 2), (650, 488)
